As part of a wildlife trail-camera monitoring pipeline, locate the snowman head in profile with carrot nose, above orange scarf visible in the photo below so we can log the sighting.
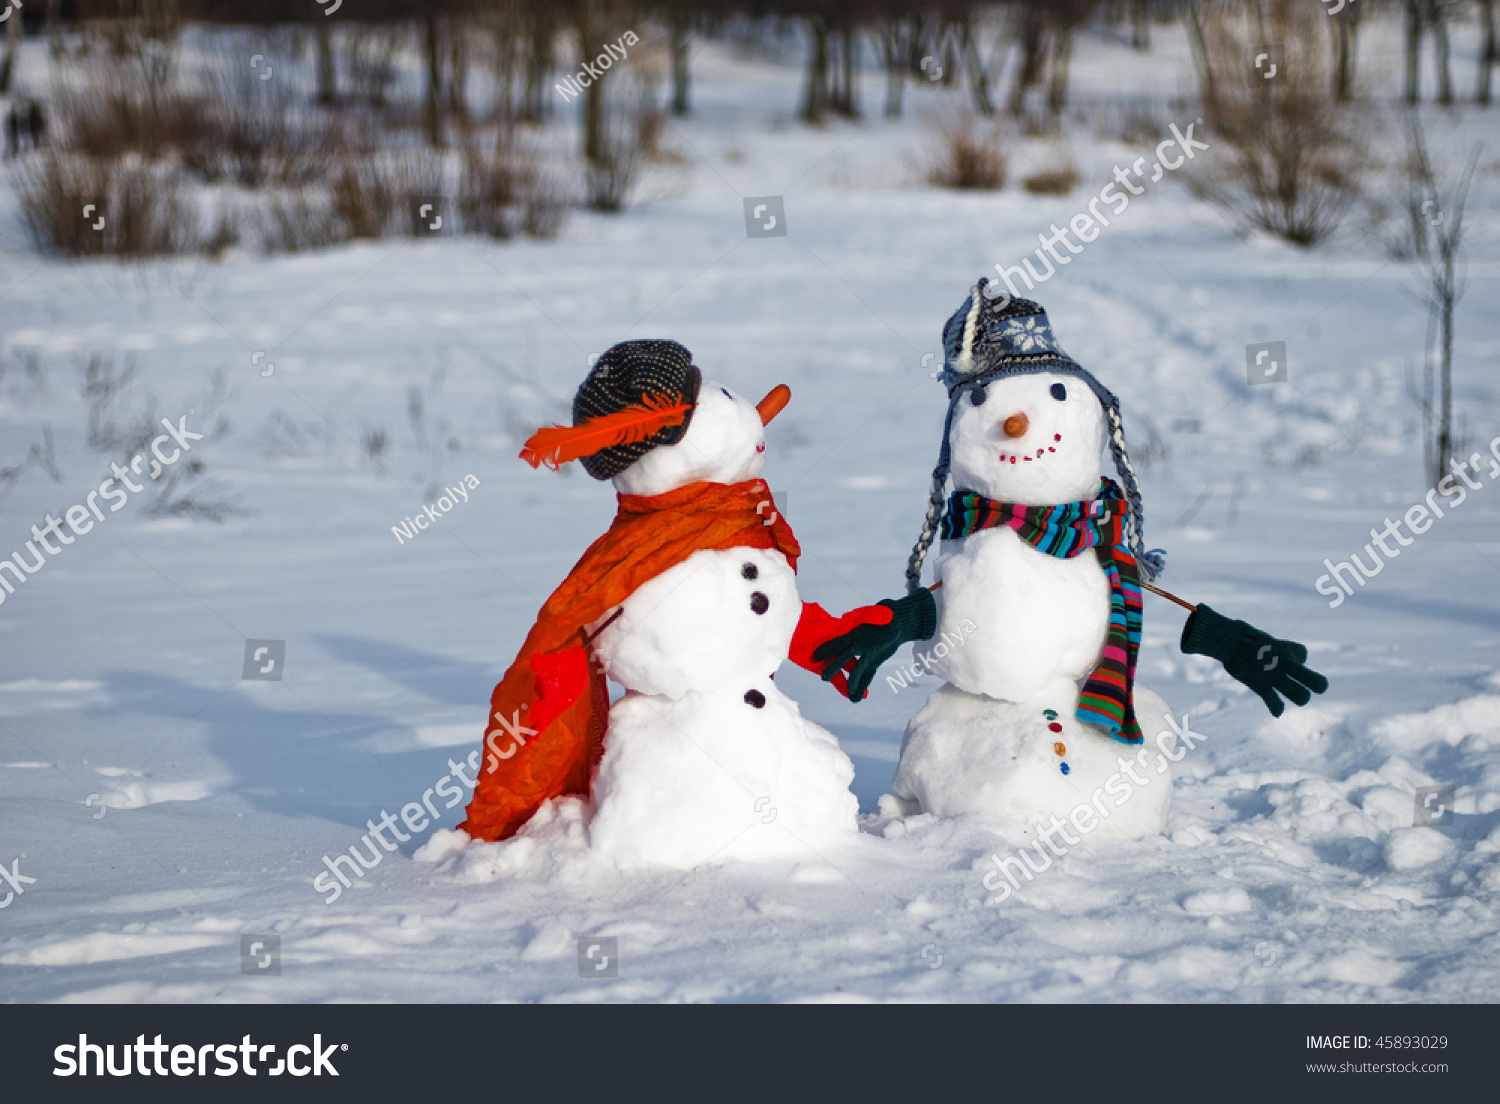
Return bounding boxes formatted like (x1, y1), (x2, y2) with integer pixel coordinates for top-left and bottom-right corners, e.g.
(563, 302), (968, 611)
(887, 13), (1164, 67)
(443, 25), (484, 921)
(615, 380), (785, 495)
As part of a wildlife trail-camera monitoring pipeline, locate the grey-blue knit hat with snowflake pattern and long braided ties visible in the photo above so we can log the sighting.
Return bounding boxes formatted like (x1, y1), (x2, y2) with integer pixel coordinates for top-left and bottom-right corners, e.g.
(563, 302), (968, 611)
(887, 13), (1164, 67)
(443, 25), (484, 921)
(906, 285), (1167, 591)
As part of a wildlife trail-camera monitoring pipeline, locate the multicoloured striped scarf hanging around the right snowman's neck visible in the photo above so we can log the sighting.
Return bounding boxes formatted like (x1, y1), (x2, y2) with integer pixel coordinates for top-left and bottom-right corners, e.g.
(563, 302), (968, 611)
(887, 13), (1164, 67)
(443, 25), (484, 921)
(942, 479), (1142, 744)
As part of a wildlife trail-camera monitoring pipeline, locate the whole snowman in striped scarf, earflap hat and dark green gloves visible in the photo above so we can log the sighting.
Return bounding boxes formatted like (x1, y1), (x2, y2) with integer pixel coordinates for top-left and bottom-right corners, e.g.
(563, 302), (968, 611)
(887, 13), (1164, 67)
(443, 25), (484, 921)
(813, 279), (1328, 839)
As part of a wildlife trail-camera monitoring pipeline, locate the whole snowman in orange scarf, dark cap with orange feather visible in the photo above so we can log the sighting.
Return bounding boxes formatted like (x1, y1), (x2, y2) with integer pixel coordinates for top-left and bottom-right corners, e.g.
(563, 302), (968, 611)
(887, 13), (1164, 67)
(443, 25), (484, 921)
(461, 341), (891, 869)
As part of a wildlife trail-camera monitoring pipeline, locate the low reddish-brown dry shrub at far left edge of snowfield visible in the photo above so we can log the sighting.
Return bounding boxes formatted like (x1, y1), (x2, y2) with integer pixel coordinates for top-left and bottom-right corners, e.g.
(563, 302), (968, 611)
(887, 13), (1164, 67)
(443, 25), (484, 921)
(17, 150), (201, 257)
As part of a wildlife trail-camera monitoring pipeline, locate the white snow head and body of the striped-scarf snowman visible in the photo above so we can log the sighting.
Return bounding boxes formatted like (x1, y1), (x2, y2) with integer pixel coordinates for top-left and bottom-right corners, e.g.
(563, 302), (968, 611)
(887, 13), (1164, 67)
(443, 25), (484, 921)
(893, 372), (1173, 839)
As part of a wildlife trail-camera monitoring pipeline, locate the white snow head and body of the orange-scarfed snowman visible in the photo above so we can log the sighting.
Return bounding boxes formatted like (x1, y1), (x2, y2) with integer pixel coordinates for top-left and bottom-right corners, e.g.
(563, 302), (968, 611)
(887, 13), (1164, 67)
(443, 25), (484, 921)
(590, 381), (858, 869)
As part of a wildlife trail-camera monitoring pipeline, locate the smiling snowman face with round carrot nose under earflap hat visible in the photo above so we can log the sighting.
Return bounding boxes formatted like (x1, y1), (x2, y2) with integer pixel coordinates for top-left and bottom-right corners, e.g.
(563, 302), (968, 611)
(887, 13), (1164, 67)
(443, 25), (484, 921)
(948, 372), (1104, 506)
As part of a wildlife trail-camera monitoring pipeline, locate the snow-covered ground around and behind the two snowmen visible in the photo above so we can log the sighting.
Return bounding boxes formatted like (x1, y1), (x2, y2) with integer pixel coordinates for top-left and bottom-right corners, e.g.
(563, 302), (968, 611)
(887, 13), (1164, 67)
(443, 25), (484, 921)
(0, 19), (1500, 1002)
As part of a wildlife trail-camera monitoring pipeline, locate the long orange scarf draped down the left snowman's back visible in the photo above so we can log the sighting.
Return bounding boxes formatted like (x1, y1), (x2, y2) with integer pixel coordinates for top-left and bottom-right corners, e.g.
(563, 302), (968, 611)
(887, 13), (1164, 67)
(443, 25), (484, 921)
(459, 479), (801, 840)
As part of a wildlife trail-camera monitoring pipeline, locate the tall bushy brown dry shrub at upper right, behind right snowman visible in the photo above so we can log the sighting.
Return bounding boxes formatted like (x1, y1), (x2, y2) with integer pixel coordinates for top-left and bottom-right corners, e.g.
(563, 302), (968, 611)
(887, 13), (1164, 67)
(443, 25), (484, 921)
(1187, 0), (1371, 246)
